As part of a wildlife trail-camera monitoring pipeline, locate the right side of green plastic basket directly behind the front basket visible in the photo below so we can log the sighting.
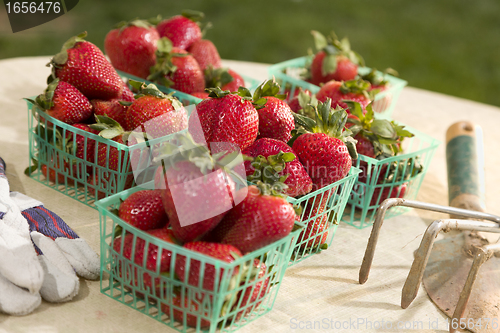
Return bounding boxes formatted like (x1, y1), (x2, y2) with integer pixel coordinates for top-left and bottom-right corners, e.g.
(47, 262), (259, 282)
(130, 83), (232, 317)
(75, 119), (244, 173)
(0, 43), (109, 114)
(287, 166), (361, 266)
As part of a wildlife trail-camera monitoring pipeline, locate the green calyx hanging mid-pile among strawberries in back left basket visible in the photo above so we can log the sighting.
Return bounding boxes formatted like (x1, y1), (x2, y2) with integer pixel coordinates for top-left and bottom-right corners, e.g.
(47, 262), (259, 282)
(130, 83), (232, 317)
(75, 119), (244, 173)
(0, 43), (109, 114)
(148, 37), (189, 87)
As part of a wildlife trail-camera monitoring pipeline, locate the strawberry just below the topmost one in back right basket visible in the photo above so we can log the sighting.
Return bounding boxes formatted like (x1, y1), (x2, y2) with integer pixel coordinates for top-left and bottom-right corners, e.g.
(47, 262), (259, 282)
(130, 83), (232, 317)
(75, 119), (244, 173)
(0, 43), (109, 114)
(316, 79), (373, 112)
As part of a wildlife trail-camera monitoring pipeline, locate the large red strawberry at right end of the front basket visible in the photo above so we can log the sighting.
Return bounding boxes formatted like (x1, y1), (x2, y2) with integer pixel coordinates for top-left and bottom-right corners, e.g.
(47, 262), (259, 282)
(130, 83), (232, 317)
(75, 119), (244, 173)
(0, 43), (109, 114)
(210, 183), (295, 254)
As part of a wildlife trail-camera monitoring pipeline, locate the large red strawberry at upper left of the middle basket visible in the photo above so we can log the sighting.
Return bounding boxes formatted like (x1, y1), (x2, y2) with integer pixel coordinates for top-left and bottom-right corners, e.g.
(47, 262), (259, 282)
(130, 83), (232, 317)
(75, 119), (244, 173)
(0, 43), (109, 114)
(188, 88), (259, 151)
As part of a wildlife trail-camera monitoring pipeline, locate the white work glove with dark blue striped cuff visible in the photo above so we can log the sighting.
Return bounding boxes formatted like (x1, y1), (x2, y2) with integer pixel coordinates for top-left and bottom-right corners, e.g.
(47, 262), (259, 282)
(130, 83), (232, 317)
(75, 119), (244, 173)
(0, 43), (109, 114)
(0, 159), (99, 315)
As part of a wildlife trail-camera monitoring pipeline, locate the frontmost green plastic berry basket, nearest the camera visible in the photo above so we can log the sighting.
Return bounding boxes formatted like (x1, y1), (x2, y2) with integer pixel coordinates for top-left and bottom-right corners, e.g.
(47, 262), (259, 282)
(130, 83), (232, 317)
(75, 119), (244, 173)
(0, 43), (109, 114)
(96, 187), (300, 332)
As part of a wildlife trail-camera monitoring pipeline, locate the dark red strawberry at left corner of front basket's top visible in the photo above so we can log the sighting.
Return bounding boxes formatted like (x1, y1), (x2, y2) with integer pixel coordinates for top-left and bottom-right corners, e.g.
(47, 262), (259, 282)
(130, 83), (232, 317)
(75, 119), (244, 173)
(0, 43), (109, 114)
(118, 190), (168, 230)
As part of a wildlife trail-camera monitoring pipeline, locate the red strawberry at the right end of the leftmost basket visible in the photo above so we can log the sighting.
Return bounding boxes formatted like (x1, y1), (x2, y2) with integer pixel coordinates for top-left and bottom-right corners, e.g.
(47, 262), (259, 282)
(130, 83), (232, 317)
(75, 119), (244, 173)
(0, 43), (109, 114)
(125, 80), (188, 138)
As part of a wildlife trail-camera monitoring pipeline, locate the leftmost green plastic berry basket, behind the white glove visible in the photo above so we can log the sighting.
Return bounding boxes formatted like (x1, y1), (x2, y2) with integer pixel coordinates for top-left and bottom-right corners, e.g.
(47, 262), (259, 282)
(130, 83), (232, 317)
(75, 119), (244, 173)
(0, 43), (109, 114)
(27, 98), (187, 209)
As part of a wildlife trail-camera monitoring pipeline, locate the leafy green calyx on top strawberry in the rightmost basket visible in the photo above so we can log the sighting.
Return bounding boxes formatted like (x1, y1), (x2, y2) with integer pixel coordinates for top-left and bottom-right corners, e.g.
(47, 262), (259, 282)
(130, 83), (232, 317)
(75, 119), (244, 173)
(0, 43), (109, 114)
(346, 101), (413, 159)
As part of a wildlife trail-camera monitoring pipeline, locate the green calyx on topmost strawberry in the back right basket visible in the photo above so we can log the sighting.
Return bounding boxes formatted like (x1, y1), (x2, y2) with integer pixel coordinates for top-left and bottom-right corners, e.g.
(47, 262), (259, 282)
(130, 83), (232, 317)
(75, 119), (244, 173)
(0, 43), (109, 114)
(311, 30), (365, 76)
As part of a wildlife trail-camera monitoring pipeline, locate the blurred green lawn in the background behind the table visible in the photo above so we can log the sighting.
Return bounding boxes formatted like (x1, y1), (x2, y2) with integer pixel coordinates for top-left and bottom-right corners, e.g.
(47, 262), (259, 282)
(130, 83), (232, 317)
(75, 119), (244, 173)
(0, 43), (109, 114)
(0, 0), (500, 106)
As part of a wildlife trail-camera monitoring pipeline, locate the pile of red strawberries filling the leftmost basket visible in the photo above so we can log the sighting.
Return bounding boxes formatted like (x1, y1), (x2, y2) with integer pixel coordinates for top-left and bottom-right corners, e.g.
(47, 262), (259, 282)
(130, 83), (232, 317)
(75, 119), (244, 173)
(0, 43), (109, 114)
(29, 33), (191, 198)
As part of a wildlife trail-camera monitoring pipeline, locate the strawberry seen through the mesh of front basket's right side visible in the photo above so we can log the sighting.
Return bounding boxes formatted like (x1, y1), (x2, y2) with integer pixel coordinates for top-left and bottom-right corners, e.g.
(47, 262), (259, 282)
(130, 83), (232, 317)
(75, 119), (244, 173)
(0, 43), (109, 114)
(233, 259), (270, 322)
